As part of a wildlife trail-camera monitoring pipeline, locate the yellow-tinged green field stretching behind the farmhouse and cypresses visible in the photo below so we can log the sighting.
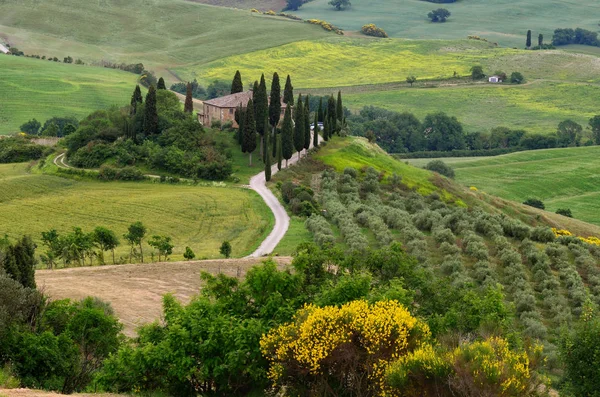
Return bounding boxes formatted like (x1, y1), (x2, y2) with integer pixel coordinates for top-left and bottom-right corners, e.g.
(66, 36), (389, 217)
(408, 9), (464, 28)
(186, 36), (600, 88)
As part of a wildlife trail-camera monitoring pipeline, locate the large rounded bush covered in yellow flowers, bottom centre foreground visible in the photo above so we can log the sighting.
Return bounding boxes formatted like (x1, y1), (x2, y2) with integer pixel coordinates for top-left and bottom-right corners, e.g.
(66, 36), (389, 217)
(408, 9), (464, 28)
(260, 300), (430, 396)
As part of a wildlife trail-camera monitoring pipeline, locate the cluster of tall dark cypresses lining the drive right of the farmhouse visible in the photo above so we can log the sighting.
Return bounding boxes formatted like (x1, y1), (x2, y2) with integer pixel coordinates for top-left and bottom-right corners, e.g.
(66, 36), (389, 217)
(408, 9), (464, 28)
(231, 70), (344, 180)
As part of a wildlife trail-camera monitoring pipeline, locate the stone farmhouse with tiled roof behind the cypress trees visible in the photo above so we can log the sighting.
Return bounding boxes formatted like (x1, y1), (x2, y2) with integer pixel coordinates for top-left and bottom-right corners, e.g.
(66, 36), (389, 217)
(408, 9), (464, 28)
(198, 90), (287, 128)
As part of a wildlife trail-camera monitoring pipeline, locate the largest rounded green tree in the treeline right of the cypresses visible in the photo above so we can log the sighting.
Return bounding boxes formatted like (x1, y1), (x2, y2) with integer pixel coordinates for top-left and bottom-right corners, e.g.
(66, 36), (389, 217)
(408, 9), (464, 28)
(423, 112), (465, 151)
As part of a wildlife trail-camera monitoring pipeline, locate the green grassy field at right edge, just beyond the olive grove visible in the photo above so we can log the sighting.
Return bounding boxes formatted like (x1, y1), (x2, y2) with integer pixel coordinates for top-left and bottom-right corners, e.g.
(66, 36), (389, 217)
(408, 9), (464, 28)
(440, 146), (600, 225)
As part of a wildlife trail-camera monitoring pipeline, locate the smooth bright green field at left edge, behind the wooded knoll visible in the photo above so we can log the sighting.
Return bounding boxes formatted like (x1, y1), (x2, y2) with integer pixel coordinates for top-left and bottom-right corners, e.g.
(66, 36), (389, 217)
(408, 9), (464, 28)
(0, 56), (137, 134)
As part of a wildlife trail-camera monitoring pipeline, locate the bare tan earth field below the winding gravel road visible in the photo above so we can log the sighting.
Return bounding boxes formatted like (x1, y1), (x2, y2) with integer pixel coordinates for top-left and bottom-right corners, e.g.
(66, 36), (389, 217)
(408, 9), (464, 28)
(36, 257), (291, 336)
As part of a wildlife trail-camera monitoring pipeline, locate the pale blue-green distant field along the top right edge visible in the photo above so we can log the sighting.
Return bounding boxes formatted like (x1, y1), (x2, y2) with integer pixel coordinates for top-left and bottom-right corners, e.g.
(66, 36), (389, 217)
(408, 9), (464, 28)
(295, 0), (600, 48)
